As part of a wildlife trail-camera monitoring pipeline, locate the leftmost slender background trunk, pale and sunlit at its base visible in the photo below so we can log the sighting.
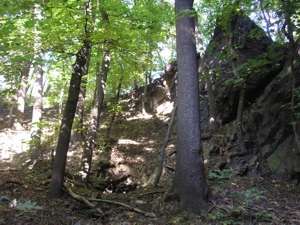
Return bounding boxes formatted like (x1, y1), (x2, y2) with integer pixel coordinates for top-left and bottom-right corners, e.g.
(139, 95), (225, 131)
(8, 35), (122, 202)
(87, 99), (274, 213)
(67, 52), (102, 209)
(17, 62), (31, 114)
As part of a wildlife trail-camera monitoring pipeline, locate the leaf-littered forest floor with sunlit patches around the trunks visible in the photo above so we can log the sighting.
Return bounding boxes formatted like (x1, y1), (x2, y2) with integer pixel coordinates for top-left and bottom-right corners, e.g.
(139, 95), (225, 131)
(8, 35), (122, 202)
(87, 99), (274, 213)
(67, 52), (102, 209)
(0, 103), (300, 225)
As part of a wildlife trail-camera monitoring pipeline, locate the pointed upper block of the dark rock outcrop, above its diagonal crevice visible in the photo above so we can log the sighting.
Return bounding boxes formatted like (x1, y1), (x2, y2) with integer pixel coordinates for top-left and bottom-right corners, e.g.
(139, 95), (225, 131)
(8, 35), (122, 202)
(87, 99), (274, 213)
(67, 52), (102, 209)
(204, 11), (283, 124)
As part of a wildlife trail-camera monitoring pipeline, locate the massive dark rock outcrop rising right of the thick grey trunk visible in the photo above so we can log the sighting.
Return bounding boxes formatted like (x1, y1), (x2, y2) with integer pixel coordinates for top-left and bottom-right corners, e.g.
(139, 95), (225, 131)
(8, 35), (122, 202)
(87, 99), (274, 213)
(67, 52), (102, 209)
(203, 12), (300, 178)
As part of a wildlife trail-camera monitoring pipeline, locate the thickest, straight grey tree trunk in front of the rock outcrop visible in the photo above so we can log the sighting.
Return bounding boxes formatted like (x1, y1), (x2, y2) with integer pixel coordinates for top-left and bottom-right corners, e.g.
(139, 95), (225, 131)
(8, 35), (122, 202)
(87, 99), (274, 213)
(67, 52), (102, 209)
(175, 0), (208, 213)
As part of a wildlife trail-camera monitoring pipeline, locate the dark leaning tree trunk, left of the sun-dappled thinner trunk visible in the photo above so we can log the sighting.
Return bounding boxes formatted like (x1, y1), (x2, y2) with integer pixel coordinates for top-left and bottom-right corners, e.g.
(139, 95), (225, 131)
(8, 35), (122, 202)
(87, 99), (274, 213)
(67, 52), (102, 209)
(50, 41), (91, 197)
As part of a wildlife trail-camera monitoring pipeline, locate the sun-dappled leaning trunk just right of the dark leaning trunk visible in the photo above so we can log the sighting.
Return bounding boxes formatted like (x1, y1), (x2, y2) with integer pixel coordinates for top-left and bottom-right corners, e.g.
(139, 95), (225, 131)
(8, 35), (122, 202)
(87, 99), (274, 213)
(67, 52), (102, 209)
(82, 49), (111, 180)
